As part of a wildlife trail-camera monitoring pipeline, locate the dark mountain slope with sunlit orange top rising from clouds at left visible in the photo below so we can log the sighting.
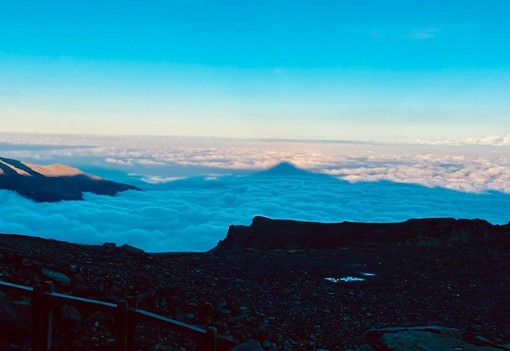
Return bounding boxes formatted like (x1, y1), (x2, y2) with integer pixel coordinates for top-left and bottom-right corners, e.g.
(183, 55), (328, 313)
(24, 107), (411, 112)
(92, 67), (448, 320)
(0, 157), (140, 202)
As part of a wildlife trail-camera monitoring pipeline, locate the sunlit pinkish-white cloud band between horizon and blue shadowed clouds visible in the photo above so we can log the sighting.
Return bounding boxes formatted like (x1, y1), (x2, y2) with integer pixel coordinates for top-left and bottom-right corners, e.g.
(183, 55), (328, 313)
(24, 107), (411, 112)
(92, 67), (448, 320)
(0, 134), (510, 192)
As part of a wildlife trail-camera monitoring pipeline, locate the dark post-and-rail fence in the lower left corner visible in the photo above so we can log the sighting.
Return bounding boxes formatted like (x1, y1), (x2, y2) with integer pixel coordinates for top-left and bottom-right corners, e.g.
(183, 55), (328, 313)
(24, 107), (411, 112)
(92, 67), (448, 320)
(0, 281), (235, 351)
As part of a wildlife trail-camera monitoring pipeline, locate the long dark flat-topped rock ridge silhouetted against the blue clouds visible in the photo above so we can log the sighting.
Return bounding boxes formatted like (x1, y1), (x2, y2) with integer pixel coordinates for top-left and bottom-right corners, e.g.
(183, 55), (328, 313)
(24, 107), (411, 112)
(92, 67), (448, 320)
(213, 216), (510, 252)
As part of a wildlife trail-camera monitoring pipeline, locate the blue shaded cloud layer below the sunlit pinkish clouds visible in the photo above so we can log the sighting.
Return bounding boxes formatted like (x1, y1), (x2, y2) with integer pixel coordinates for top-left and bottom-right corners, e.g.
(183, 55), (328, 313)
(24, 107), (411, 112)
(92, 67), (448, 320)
(0, 167), (510, 252)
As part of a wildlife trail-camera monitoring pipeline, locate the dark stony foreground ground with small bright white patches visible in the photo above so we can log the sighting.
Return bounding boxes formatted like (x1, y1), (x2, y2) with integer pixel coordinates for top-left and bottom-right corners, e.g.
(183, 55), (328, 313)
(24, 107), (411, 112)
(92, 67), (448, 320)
(0, 235), (510, 351)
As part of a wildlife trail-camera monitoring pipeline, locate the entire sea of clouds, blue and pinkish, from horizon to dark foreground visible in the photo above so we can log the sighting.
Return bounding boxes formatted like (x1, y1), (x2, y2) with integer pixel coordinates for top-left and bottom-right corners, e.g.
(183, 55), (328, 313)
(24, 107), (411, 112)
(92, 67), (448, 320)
(0, 134), (510, 252)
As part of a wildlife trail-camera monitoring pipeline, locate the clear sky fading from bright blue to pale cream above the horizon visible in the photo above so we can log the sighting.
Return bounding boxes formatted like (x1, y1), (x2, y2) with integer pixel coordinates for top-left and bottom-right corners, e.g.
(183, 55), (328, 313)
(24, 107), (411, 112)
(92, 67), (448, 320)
(0, 0), (510, 140)
